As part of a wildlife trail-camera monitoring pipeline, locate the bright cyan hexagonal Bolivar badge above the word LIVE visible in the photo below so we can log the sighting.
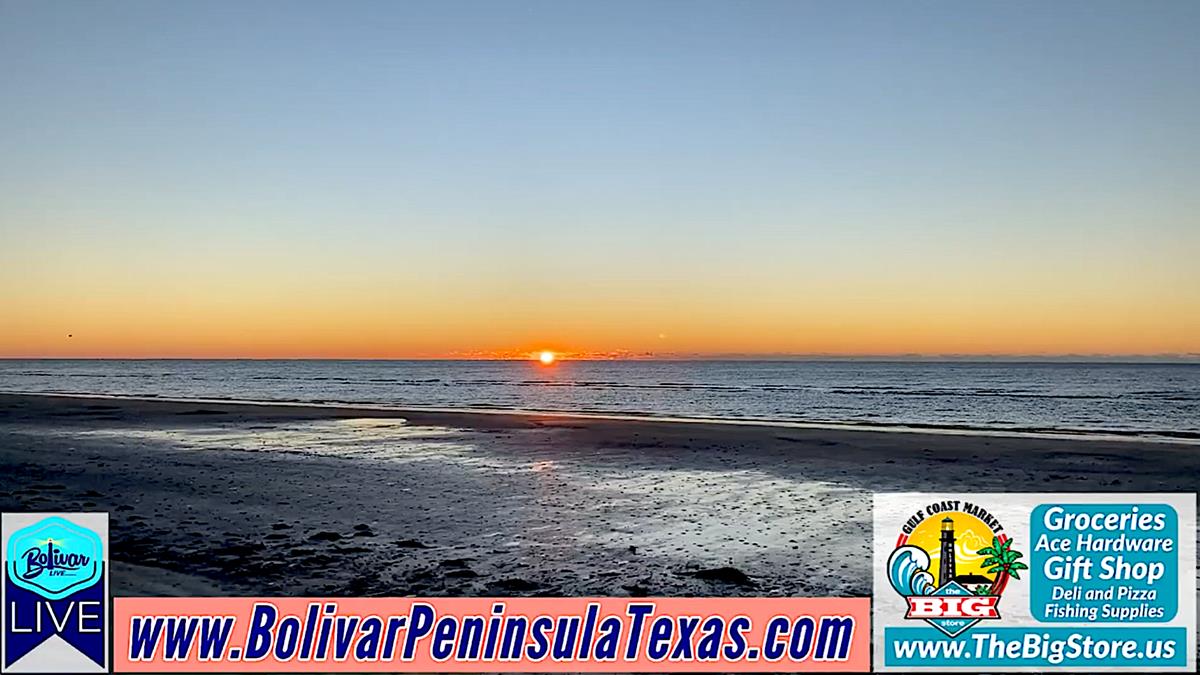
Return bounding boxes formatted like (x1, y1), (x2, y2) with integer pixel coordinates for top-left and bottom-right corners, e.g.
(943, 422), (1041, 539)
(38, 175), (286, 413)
(6, 516), (104, 601)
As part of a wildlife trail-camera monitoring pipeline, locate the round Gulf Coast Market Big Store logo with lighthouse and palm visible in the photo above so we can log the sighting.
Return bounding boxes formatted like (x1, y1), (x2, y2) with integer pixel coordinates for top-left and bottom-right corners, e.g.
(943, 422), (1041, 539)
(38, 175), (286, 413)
(887, 500), (1027, 638)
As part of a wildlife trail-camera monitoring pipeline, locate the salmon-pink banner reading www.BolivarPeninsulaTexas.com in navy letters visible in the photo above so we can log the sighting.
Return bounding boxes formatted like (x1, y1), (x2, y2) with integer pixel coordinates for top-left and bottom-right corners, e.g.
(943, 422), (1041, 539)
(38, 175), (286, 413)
(113, 598), (870, 673)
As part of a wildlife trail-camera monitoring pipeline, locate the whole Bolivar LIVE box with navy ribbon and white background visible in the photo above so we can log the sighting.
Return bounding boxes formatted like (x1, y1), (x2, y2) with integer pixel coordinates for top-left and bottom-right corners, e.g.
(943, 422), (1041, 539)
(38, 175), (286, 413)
(0, 513), (108, 673)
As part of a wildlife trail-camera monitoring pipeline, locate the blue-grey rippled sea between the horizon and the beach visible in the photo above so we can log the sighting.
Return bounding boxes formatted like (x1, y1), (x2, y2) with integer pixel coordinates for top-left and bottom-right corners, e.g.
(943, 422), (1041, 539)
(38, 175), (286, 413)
(0, 360), (1200, 438)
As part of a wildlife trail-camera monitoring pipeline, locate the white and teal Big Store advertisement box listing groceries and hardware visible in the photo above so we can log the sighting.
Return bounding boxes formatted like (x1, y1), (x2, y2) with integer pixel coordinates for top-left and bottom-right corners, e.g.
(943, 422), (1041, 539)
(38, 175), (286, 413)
(872, 492), (1196, 673)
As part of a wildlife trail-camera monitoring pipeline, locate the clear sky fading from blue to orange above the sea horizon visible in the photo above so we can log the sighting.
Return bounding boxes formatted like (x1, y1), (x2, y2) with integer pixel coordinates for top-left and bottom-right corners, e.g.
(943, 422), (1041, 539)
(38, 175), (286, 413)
(0, 0), (1200, 357)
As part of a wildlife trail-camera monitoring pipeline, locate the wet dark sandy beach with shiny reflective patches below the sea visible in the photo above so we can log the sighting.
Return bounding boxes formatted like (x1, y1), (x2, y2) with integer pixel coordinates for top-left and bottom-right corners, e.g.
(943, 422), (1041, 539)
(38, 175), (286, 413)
(0, 394), (1200, 596)
